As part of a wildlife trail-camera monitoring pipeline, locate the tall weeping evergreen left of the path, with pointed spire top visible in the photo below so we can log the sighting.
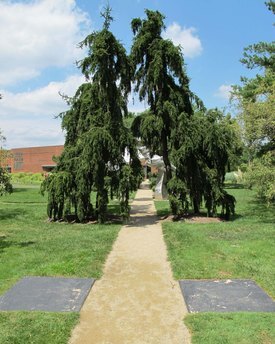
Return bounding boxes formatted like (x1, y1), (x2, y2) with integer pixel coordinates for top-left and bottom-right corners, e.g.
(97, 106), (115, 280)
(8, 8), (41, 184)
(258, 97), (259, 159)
(42, 7), (141, 223)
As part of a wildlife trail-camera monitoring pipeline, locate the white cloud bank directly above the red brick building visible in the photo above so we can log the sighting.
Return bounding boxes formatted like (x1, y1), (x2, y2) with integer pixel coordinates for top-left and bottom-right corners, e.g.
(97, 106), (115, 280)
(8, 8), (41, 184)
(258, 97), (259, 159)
(0, 75), (84, 148)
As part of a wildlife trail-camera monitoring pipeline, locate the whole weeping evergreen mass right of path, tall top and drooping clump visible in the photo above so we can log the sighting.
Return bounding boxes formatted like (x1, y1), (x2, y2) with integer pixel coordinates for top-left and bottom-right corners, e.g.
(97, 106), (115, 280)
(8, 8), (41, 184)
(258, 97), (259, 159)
(131, 10), (235, 217)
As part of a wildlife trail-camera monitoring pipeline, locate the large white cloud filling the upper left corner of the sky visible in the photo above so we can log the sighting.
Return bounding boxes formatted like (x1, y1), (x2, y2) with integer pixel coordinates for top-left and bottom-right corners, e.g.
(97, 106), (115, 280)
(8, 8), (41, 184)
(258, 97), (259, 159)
(0, 0), (90, 87)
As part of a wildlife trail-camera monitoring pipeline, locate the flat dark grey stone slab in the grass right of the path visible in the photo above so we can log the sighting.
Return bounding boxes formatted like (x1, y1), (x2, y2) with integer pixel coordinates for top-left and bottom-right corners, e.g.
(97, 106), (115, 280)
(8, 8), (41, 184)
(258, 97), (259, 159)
(179, 279), (275, 313)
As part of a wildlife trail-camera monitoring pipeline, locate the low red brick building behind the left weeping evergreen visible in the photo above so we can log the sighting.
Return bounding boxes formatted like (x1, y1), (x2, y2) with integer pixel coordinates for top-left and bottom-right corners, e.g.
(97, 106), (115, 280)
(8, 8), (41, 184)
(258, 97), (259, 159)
(8, 145), (64, 173)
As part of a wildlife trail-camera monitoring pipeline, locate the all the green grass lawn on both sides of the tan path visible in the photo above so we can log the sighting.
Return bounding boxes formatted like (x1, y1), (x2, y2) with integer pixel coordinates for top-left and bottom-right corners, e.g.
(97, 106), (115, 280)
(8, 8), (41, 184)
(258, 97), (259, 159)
(0, 185), (275, 344)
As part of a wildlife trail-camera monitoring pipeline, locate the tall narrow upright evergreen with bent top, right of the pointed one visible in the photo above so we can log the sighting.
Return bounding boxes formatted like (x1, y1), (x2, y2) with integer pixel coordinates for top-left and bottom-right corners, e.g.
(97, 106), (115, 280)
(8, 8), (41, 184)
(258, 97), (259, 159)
(131, 10), (195, 181)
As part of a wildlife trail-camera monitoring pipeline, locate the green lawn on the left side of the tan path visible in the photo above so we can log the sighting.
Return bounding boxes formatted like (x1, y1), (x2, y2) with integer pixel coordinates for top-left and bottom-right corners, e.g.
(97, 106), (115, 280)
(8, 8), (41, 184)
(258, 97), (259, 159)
(0, 186), (121, 344)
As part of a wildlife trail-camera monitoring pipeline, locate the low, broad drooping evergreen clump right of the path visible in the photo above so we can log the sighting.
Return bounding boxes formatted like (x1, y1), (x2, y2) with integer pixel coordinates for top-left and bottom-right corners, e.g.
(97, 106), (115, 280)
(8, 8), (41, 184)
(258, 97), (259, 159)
(168, 109), (241, 219)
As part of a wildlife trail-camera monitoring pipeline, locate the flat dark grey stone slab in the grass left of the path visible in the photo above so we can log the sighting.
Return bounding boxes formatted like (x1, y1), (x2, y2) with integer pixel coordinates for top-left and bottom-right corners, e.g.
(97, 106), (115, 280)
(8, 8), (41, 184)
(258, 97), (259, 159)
(0, 277), (95, 312)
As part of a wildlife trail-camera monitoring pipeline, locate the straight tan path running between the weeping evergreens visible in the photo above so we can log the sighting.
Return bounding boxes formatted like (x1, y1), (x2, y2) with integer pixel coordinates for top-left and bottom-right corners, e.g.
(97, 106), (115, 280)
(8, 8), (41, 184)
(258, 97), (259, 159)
(70, 183), (190, 344)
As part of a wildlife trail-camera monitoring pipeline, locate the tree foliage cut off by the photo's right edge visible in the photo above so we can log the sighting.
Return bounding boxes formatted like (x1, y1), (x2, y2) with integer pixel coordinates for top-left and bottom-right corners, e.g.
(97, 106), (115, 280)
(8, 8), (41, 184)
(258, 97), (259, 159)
(233, 1), (275, 203)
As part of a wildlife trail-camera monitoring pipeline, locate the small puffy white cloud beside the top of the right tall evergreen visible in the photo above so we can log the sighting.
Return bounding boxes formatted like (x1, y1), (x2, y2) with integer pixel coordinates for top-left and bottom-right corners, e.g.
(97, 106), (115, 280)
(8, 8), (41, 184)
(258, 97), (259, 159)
(163, 23), (202, 58)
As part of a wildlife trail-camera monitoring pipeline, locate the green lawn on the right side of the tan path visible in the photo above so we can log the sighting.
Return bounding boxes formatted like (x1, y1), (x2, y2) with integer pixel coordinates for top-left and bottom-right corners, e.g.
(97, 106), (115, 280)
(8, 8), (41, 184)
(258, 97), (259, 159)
(156, 188), (275, 344)
